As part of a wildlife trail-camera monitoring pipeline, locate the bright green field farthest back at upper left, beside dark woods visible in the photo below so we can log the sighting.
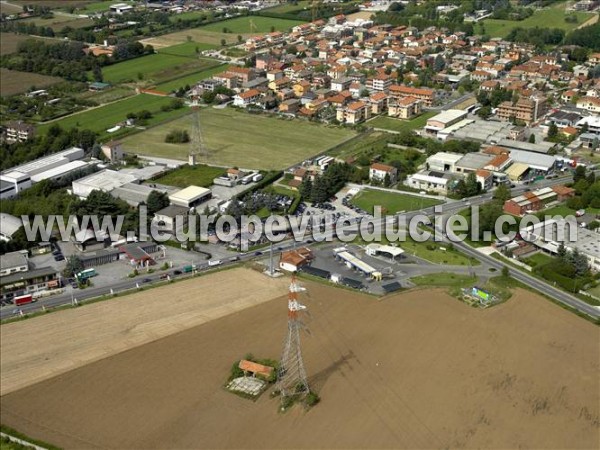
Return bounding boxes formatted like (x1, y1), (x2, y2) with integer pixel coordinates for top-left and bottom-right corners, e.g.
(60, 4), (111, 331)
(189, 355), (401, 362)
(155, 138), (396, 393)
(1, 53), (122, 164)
(102, 53), (220, 84)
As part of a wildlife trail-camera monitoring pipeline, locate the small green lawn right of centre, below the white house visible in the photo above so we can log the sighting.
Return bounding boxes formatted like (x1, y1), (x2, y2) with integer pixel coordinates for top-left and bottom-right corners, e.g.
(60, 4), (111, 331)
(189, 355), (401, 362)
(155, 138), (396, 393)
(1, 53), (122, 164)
(352, 189), (444, 214)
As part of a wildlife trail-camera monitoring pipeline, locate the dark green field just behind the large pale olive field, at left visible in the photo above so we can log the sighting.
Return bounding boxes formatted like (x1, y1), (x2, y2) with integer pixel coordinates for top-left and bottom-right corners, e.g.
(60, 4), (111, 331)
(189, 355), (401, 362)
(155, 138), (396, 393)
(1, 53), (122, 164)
(38, 94), (189, 140)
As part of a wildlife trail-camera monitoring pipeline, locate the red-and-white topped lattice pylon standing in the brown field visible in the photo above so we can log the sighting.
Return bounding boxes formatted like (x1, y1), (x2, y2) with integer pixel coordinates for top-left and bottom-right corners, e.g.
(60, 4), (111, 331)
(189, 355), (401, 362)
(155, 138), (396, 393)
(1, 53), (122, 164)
(277, 276), (310, 402)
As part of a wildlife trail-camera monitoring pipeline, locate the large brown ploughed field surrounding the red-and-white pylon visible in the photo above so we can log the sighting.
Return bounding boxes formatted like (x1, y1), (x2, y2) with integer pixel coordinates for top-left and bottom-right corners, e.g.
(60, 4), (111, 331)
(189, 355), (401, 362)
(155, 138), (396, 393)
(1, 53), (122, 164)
(1, 283), (600, 449)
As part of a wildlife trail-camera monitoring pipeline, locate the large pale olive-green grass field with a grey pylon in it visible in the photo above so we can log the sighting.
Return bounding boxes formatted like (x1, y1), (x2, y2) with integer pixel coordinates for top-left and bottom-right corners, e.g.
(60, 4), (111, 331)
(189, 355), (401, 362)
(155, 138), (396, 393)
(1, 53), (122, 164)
(123, 108), (354, 169)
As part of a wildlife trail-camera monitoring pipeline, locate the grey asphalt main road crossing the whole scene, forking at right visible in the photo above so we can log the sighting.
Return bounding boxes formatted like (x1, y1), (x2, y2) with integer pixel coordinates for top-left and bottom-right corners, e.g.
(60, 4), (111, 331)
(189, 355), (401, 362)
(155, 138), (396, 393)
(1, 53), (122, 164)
(0, 173), (600, 320)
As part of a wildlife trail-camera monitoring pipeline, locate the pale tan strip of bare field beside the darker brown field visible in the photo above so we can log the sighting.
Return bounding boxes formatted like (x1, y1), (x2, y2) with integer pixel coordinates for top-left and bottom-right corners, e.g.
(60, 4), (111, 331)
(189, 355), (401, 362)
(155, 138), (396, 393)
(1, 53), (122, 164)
(0, 269), (286, 395)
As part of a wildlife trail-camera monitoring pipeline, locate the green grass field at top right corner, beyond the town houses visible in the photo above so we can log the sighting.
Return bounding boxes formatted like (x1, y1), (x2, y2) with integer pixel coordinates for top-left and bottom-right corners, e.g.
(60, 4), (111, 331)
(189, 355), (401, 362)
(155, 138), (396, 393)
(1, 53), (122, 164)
(475, 2), (593, 37)
